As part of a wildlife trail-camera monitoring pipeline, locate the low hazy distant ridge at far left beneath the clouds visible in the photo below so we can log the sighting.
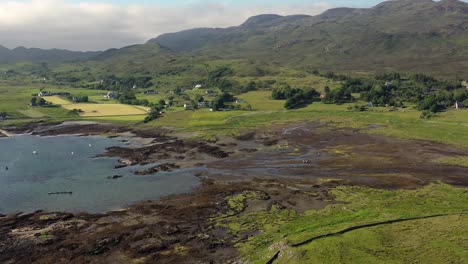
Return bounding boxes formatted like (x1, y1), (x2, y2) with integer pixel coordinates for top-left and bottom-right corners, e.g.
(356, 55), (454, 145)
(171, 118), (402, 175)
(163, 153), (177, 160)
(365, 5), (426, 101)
(0, 45), (101, 63)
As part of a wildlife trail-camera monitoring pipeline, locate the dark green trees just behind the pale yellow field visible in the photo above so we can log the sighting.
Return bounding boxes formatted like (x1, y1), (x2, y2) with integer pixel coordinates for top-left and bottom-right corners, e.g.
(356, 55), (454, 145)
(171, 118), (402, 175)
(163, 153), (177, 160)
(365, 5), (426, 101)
(95, 75), (153, 91)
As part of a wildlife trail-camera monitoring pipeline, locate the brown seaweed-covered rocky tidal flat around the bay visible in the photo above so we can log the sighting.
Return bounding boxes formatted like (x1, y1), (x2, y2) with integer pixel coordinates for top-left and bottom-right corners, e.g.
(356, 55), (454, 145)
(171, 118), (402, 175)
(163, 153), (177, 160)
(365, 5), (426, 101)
(0, 122), (468, 263)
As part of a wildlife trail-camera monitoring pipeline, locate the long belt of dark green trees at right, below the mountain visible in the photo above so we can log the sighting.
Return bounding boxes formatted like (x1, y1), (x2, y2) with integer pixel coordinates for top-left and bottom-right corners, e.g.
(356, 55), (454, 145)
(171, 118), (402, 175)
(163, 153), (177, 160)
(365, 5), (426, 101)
(318, 72), (462, 113)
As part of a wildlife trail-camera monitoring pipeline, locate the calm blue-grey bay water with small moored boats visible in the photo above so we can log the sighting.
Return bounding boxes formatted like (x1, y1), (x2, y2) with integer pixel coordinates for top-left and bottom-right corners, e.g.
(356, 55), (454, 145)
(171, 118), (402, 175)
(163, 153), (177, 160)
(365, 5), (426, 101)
(0, 136), (199, 213)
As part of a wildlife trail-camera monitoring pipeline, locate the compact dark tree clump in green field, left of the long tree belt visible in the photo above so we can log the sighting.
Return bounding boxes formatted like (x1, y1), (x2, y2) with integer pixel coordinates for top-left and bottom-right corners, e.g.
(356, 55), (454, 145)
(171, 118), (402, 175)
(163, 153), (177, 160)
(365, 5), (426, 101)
(271, 86), (320, 109)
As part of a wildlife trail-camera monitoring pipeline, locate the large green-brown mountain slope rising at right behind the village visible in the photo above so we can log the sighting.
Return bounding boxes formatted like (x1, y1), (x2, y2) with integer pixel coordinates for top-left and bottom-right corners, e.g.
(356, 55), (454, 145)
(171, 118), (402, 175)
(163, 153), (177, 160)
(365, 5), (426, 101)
(149, 0), (468, 75)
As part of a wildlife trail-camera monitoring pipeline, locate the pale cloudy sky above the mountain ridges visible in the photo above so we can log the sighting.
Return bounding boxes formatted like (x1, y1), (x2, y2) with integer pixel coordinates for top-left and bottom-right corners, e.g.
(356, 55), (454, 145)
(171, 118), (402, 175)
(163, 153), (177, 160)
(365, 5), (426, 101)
(0, 0), (333, 50)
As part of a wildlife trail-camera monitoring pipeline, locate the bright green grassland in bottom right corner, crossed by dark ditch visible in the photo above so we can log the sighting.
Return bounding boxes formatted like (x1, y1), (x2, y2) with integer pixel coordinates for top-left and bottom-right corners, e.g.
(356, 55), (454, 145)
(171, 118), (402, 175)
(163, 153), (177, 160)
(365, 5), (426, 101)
(217, 183), (468, 263)
